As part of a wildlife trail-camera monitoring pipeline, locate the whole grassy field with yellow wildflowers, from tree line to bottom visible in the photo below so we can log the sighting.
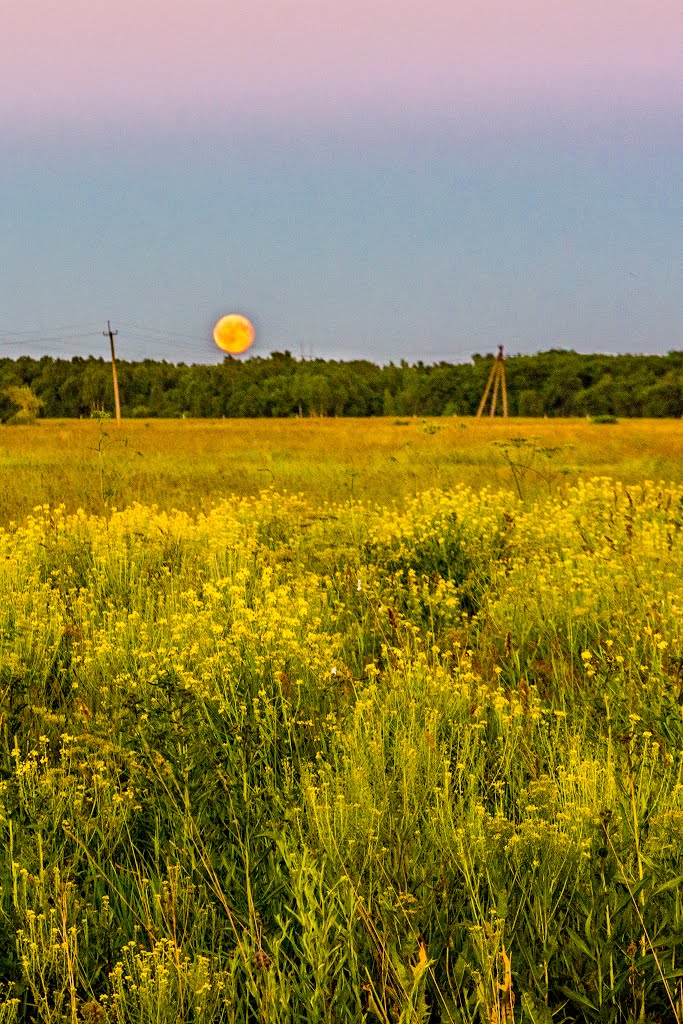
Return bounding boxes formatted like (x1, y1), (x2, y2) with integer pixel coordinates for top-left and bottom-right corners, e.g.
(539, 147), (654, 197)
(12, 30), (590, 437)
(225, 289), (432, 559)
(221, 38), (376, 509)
(0, 419), (683, 1024)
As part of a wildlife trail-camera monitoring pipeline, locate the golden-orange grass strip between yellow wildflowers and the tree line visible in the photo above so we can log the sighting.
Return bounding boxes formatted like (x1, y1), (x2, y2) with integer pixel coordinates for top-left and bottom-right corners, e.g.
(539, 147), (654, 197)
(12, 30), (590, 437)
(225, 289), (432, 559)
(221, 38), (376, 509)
(0, 417), (683, 522)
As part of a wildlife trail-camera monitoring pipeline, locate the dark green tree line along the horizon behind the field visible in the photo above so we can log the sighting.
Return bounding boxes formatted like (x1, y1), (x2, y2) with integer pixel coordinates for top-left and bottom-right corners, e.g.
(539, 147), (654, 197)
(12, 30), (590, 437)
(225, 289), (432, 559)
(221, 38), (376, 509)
(0, 349), (683, 422)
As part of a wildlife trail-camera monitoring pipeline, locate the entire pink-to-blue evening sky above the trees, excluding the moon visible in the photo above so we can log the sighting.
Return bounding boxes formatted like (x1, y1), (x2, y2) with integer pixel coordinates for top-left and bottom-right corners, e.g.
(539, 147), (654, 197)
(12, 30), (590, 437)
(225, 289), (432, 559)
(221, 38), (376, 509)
(0, 0), (683, 364)
